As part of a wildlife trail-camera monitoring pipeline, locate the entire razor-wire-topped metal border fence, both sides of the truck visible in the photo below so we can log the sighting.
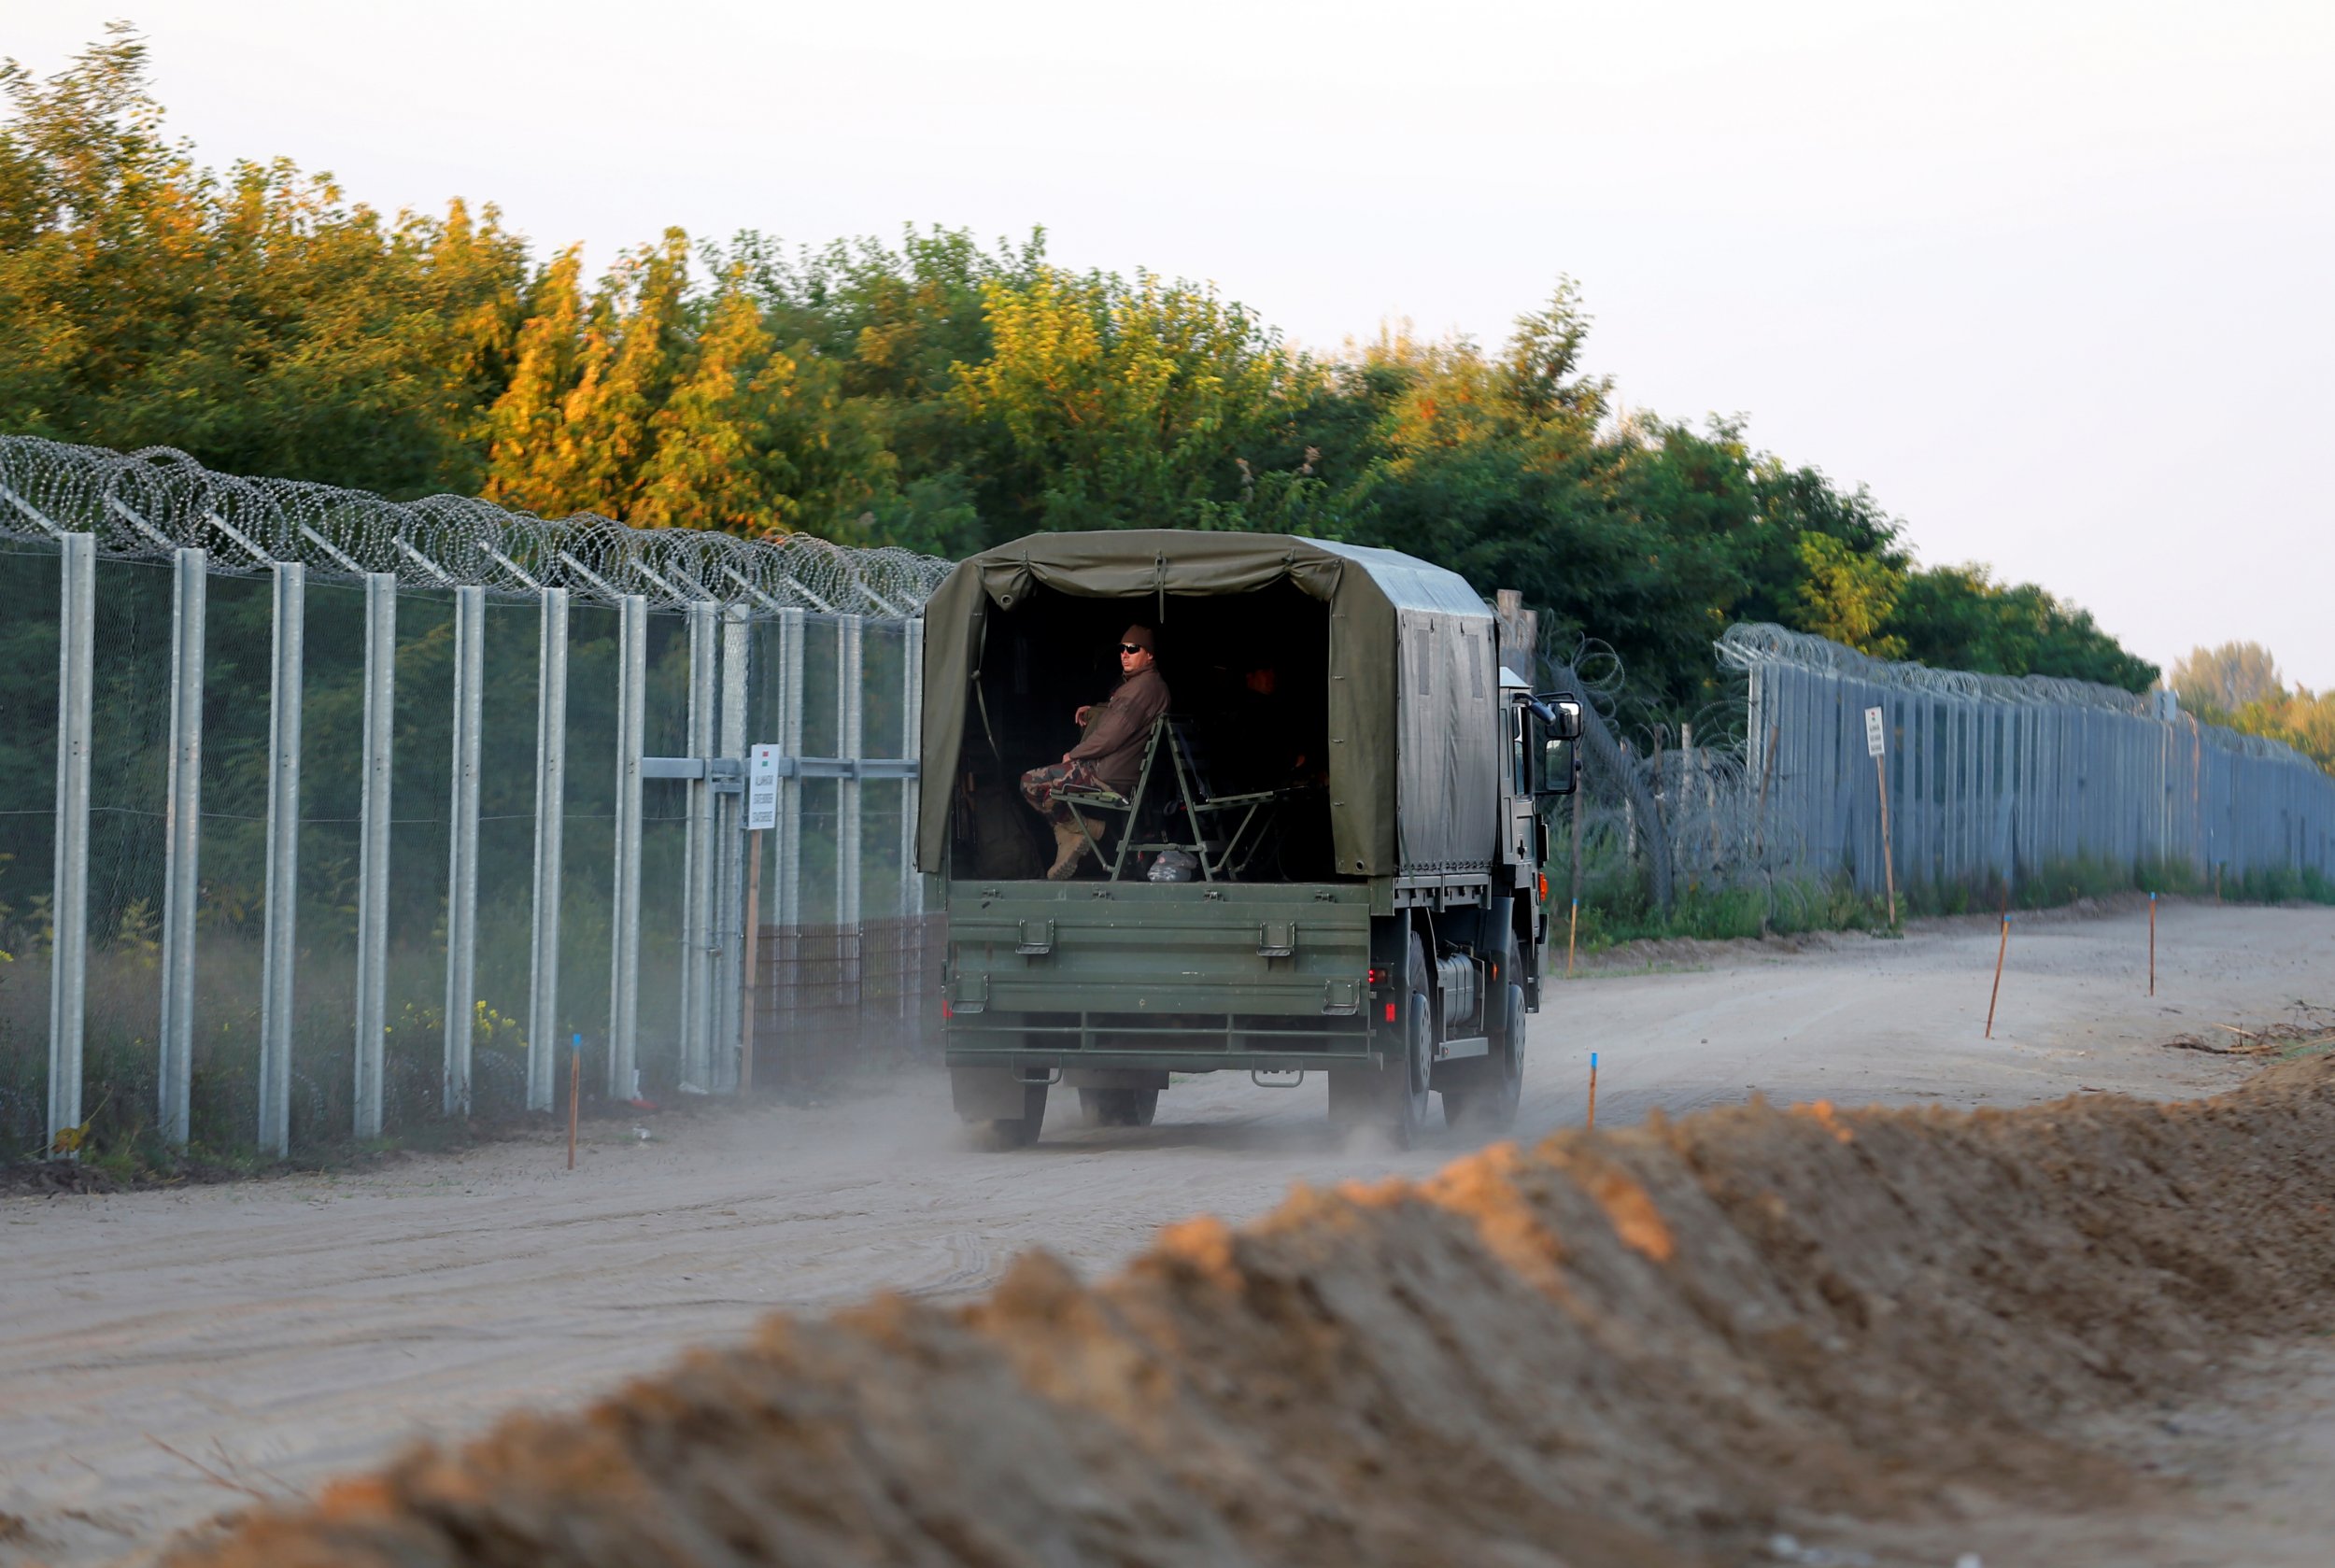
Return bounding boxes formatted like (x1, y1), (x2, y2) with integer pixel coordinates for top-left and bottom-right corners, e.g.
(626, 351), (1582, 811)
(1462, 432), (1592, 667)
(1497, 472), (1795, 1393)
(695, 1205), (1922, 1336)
(0, 436), (2335, 1157)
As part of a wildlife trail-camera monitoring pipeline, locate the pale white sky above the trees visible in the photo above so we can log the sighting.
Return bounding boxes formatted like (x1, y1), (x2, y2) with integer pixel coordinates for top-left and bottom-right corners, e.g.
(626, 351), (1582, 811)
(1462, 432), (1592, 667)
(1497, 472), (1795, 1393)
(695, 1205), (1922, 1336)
(18, 0), (2335, 688)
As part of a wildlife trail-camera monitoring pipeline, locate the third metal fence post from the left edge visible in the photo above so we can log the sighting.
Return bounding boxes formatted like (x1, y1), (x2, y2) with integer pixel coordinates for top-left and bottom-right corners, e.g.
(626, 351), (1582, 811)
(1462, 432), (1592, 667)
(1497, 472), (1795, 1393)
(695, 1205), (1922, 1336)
(260, 560), (308, 1157)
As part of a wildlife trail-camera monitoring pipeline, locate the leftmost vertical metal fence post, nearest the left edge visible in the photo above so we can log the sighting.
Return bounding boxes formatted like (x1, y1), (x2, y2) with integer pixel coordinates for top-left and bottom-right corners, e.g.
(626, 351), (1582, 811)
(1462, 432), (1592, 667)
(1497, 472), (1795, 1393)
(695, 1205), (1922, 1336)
(50, 534), (98, 1152)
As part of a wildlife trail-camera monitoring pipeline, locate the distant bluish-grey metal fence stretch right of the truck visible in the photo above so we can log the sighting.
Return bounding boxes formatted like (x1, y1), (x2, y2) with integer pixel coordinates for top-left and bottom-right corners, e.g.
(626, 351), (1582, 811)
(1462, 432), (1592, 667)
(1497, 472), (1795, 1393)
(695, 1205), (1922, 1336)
(1574, 626), (2335, 912)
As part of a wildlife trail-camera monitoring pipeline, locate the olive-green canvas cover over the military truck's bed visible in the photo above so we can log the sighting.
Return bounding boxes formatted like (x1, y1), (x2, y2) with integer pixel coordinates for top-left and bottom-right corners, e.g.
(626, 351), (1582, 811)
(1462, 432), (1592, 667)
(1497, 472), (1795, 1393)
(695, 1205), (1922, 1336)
(915, 530), (1499, 877)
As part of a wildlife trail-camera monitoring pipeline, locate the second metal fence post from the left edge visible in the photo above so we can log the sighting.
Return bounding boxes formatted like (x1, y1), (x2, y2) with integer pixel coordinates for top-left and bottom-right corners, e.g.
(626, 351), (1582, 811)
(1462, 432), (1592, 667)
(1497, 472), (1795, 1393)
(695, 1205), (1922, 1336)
(159, 551), (210, 1148)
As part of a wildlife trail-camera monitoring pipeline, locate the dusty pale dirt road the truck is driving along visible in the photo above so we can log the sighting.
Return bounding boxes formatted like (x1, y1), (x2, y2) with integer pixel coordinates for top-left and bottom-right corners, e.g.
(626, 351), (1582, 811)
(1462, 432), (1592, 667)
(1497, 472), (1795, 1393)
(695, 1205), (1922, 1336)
(0, 905), (2335, 1563)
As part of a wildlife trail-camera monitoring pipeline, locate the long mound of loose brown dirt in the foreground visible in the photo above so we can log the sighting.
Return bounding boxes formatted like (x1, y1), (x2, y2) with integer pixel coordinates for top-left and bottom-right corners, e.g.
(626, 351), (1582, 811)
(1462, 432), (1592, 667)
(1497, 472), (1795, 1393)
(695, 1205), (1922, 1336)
(180, 1062), (2335, 1568)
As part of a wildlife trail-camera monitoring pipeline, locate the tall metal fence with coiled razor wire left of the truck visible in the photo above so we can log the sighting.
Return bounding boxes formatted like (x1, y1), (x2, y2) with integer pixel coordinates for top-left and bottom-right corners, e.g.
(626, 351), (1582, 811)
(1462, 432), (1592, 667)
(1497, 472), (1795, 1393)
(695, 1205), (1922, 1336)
(0, 436), (948, 1155)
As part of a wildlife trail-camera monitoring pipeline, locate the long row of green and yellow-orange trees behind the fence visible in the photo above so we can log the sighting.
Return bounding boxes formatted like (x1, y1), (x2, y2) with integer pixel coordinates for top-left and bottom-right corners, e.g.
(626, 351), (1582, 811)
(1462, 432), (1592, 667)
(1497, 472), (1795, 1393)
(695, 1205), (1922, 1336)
(0, 28), (2158, 724)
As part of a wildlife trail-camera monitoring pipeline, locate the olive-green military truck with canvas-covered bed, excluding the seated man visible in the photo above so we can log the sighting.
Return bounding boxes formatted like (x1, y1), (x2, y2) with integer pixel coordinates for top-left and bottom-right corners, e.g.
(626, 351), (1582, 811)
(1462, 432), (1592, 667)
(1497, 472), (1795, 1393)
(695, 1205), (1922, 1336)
(918, 530), (1581, 1148)
